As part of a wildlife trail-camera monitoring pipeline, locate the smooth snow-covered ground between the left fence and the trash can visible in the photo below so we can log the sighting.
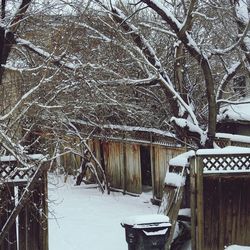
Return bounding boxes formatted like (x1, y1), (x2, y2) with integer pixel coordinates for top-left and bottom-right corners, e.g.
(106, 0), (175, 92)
(49, 176), (158, 250)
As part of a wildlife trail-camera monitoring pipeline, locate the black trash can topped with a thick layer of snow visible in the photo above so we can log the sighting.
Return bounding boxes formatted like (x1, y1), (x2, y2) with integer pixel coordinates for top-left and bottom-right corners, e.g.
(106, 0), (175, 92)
(121, 214), (171, 250)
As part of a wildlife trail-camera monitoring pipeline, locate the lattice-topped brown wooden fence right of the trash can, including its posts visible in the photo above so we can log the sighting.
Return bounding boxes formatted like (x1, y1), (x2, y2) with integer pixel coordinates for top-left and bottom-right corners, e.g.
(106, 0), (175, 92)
(190, 149), (250, 250)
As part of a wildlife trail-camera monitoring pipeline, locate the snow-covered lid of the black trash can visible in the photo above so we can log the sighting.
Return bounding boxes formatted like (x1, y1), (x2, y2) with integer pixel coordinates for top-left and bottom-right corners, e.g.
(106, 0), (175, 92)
(121, 214), (171, 228)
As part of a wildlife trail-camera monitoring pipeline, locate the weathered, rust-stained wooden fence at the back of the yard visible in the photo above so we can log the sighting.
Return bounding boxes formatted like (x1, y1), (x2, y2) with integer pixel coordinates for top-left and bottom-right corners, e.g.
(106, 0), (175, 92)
(61, 139), (185, 199)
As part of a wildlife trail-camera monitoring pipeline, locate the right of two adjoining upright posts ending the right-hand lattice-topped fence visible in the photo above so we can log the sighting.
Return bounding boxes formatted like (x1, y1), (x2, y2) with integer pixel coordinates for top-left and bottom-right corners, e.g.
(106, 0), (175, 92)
(196, 157), (204, 250)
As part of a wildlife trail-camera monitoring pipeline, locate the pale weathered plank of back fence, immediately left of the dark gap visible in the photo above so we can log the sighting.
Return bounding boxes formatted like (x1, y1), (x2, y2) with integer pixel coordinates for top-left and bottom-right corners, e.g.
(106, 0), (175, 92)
(125, 144), (142, 194)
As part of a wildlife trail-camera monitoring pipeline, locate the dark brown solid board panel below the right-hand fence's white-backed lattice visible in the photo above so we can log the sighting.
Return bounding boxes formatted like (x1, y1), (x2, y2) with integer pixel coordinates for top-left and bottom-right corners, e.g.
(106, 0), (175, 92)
(203, 176), (250, 250)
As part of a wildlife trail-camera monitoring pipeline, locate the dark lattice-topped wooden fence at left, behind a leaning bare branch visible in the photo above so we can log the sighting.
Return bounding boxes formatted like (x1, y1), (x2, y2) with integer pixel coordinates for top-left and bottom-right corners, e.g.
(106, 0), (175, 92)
(0, 155), (48, 250)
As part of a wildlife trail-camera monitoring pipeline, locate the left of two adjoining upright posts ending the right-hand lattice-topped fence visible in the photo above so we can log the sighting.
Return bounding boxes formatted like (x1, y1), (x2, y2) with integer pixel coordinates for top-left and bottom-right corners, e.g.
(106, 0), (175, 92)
(190, 157), (197, 250)
